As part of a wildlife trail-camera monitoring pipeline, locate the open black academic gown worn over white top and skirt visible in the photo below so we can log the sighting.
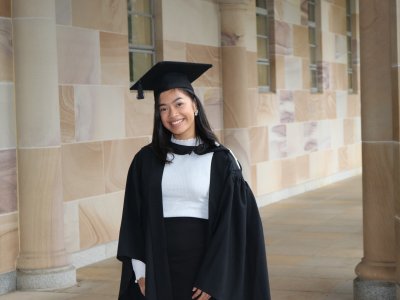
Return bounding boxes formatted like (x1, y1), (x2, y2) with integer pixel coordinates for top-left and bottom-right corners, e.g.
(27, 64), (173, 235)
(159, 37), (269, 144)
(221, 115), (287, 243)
(117, 145), (270, 300)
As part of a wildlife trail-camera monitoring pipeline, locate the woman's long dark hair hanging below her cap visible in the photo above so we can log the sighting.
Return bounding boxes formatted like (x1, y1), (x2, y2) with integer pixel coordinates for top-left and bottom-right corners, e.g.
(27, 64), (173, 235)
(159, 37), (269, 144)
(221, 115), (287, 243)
(152, 88), (219, 163)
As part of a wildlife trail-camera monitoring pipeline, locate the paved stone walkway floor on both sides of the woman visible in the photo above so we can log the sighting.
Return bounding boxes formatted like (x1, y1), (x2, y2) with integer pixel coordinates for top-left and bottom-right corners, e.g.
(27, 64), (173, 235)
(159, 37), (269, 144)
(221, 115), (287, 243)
(0, 176), (362, 300)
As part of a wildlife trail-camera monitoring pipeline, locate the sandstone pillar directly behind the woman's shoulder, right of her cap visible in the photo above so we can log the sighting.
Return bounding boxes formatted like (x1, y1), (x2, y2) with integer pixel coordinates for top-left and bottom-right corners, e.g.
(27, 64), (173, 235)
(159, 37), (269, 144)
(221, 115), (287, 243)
(218, 0), (257, 182)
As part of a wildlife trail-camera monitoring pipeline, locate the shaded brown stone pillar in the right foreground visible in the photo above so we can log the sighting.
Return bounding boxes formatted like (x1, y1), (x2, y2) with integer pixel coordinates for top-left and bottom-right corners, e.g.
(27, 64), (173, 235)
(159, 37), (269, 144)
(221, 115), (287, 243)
(354, 0), (400, 300)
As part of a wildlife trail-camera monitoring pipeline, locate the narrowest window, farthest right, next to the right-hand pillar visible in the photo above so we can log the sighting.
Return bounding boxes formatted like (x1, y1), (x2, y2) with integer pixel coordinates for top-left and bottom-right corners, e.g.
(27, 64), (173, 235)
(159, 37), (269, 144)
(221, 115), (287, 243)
(346, 0), (356, 93)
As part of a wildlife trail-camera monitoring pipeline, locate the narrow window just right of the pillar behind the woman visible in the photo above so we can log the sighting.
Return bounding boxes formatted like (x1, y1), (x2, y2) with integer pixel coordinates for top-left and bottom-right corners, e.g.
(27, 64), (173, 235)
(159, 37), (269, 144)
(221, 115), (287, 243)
(256, 0), (273, 92)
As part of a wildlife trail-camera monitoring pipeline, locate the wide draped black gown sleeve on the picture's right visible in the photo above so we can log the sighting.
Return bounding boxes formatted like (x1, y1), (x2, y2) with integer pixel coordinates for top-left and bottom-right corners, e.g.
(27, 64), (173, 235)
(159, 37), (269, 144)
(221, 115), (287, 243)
(195, 152), (270, 300)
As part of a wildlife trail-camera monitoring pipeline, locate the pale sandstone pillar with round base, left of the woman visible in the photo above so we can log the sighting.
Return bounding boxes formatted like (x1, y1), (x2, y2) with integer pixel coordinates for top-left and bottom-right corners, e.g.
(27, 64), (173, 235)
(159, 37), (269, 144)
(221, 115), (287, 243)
(12, 0), (76, 290)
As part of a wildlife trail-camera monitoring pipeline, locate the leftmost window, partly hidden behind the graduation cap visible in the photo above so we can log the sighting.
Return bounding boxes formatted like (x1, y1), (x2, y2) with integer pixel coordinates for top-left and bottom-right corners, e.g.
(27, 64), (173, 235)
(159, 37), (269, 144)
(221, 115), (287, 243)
(127, 0), (155, 83)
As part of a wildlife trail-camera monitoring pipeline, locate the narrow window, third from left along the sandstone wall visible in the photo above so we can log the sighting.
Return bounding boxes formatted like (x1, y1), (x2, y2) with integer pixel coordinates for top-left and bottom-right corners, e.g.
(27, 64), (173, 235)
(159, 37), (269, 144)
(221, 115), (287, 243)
(308, 0), (322, 93)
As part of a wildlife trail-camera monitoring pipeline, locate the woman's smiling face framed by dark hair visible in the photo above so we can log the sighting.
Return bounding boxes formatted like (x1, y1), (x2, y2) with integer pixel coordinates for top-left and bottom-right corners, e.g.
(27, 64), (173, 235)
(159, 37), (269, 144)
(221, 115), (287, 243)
(159, 89), (197, 140)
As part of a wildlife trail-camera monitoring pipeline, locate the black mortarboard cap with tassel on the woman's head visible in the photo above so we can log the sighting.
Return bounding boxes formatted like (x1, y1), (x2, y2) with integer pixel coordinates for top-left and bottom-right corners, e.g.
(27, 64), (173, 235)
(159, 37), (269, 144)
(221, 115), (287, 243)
(130, 61), (212, 99)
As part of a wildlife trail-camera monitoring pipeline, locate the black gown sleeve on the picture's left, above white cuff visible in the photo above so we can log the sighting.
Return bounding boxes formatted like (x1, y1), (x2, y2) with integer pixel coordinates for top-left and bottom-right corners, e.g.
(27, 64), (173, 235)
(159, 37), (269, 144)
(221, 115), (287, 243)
(117, 152), (146, 299)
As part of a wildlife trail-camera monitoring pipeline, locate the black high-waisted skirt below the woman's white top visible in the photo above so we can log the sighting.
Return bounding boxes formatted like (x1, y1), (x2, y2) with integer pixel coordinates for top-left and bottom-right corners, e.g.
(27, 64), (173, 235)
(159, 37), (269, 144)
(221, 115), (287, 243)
(164, 217), (208, 300)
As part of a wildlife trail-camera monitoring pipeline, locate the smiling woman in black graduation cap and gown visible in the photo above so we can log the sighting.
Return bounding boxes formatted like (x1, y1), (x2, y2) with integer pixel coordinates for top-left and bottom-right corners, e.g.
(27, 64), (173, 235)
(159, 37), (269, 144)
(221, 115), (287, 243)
(117, 62), (270, 300)
